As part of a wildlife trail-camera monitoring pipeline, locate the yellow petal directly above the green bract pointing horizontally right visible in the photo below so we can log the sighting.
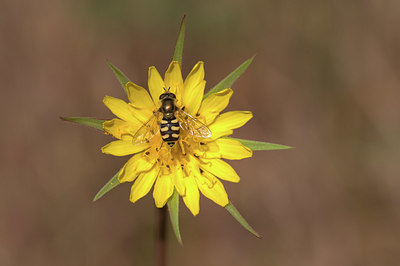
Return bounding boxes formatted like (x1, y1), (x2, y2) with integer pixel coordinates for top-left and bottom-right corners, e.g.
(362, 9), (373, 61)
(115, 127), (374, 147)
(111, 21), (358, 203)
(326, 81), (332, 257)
(208, 111), (253, 139)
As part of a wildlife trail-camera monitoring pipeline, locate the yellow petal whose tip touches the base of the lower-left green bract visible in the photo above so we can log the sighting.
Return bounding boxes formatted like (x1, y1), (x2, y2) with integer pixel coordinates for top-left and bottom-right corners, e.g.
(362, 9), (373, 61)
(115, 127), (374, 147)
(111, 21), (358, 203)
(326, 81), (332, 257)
(118, 153), (155, 183)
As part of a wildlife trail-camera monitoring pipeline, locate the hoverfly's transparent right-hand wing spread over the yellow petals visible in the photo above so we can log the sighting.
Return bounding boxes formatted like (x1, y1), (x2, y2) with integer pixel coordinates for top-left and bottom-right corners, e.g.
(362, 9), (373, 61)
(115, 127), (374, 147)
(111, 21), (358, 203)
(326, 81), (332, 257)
(176, 109), (211, 138)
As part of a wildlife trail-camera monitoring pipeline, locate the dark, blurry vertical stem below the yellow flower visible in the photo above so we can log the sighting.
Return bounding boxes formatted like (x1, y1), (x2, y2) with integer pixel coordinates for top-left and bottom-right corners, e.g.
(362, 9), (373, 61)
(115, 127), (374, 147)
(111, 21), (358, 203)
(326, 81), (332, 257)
(155, 207), (167, 266)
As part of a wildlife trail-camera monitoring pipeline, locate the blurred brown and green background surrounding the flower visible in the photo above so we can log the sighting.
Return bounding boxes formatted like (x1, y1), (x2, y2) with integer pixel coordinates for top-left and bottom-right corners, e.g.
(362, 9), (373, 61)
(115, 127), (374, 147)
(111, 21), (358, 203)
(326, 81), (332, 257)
(0, 0), (400, 266)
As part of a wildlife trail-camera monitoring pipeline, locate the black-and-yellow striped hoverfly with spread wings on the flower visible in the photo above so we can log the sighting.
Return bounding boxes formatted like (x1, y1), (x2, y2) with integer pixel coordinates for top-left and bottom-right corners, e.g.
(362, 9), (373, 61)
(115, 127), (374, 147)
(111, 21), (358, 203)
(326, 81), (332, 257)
(133, 88), (211, 147)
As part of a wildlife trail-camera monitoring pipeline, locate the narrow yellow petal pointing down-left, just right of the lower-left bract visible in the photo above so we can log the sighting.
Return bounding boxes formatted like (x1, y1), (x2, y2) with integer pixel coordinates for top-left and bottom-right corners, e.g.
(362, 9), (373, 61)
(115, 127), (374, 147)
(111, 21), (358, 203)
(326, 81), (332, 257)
(129, 166), (160, 203)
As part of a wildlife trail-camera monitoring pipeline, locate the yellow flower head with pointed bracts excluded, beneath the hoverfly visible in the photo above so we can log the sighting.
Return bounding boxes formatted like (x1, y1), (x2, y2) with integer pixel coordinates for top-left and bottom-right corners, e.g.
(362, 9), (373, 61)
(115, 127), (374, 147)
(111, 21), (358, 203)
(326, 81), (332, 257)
(102, 61), (252, 215)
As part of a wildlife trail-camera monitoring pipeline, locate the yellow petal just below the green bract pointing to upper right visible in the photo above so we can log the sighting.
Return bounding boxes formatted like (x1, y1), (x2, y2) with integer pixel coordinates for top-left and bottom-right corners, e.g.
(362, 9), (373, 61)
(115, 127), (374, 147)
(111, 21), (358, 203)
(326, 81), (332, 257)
(198, 89), (233, 125)
